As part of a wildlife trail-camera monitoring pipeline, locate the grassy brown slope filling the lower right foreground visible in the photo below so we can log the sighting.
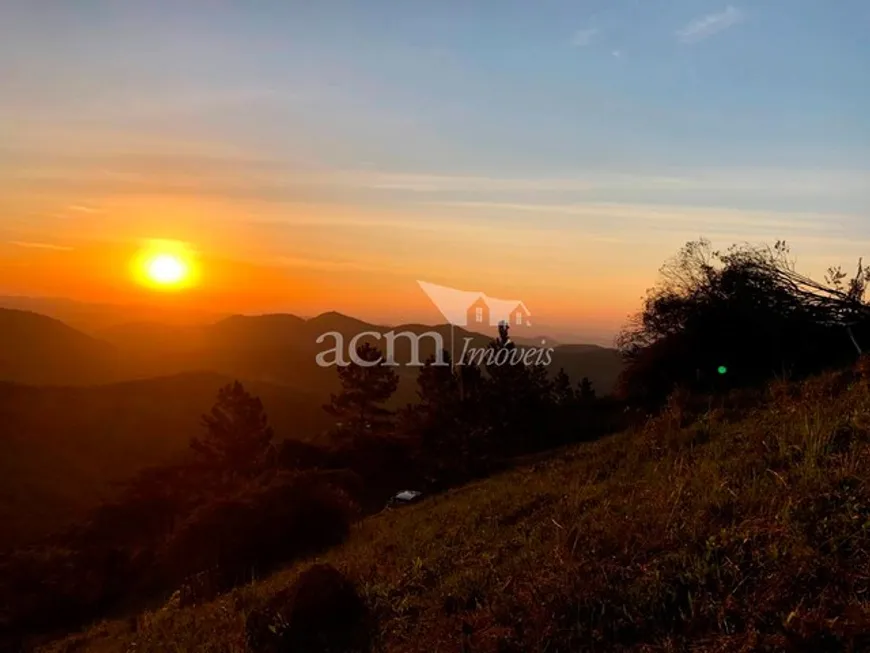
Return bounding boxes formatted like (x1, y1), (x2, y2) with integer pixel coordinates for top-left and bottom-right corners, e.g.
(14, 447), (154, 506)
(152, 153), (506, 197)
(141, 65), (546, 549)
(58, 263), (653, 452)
(42, 370), (870, 653)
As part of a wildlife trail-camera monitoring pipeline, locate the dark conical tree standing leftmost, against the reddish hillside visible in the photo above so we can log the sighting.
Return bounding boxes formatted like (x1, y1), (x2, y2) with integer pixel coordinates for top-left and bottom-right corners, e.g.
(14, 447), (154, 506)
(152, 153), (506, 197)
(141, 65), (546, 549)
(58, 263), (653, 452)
(190, 381), (273, 476)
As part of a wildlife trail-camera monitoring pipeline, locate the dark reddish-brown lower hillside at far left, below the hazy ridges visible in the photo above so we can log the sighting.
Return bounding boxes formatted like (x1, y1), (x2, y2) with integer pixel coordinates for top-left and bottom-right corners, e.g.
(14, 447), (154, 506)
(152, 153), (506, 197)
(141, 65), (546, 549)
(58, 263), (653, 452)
(0, 373), (329, 549)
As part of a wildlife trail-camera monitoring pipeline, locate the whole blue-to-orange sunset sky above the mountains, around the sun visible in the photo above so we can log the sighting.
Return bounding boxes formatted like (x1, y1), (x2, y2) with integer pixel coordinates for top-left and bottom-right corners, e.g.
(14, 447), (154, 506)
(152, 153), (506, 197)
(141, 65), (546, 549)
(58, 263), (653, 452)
(0, 0), (870, 341)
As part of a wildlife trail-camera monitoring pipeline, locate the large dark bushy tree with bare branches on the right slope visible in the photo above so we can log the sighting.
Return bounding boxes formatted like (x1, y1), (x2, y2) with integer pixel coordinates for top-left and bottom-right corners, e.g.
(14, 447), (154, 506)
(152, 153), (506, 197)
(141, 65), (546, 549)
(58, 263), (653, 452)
(618, 240), (870, 404)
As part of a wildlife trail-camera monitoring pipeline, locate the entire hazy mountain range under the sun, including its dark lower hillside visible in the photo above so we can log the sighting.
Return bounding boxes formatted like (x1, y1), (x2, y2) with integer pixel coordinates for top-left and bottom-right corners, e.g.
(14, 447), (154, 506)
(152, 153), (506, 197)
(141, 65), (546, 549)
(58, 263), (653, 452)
(0, 300), (621, 548)
